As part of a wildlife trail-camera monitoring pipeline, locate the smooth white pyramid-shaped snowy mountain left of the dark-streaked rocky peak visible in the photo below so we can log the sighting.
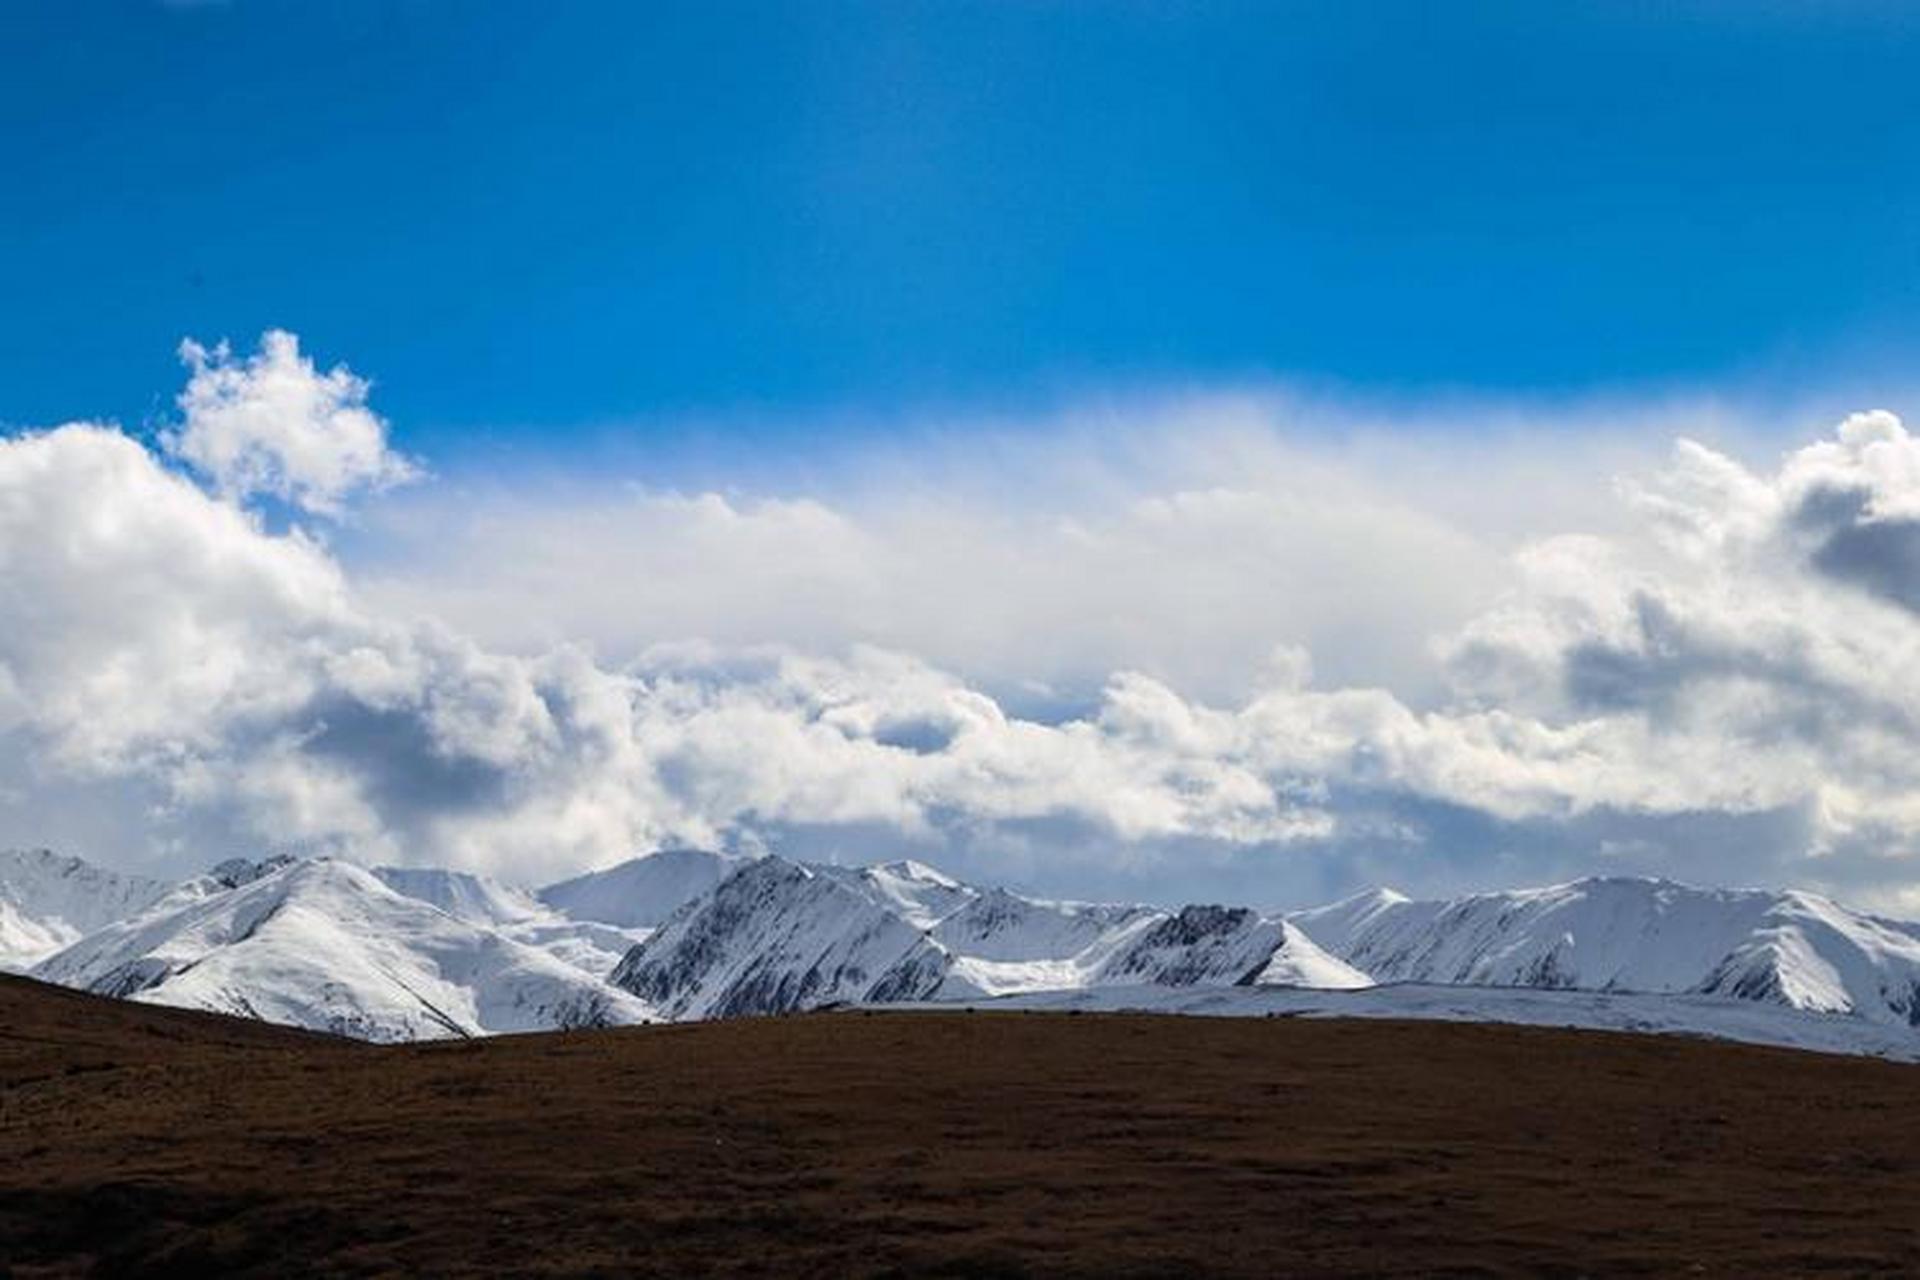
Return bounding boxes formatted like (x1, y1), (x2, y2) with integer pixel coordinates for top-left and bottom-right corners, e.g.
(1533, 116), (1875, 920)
(33, 860), (651, 1040)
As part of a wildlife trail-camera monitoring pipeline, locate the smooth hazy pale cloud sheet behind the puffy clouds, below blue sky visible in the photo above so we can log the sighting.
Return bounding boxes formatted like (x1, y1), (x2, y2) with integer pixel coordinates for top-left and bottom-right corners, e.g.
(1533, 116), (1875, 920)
(359, 397), (1647, 706)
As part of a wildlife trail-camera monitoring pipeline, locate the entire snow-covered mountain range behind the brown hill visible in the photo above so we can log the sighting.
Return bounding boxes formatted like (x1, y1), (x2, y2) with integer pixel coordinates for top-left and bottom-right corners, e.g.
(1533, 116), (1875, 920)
(0, 850), (1920, 1055)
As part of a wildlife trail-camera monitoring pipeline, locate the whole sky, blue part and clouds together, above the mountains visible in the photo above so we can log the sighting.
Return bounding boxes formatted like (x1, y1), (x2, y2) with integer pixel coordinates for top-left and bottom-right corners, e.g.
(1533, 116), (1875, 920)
(15, 0), (1920, 915)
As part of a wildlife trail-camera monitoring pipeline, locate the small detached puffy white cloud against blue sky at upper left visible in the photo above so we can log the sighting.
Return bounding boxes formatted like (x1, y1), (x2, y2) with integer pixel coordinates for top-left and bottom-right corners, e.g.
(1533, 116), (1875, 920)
(161, 330), (419, 516)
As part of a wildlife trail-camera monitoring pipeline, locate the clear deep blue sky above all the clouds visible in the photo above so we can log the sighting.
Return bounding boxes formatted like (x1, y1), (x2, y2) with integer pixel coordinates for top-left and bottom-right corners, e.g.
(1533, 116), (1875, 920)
(11, 0), (1920, 454)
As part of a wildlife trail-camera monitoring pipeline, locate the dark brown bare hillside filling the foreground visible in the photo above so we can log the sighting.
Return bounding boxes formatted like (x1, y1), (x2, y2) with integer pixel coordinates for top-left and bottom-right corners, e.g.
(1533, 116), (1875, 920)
(0, 981), (1920, 1276)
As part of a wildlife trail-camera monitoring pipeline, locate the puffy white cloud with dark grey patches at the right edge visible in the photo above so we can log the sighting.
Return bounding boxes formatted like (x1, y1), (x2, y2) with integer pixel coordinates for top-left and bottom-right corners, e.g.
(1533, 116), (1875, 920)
(1448, 413), (1920, 885)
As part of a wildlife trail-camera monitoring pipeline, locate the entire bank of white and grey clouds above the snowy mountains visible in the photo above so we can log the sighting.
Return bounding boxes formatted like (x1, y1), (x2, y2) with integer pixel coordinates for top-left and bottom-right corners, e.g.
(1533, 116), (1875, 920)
(0, 334), (1920, 910)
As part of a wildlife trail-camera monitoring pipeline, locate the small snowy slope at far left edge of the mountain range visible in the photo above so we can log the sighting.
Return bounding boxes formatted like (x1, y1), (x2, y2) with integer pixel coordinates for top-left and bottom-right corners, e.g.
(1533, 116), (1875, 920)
(0, 848), (169, 971)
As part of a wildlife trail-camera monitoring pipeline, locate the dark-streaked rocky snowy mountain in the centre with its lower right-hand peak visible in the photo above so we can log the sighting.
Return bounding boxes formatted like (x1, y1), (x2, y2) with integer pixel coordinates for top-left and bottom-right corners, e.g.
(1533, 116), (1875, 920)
(612, 858), (1367, 1017)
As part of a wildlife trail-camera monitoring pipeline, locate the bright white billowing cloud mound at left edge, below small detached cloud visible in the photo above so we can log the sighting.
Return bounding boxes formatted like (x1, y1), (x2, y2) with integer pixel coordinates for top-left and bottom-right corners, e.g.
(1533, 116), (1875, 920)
(0, 426), (349, 770)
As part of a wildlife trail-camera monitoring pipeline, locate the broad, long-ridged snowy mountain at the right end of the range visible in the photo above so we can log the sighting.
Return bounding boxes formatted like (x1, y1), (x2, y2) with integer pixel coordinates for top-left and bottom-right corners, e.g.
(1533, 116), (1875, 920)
(1288, 877), (1920, 1027)
